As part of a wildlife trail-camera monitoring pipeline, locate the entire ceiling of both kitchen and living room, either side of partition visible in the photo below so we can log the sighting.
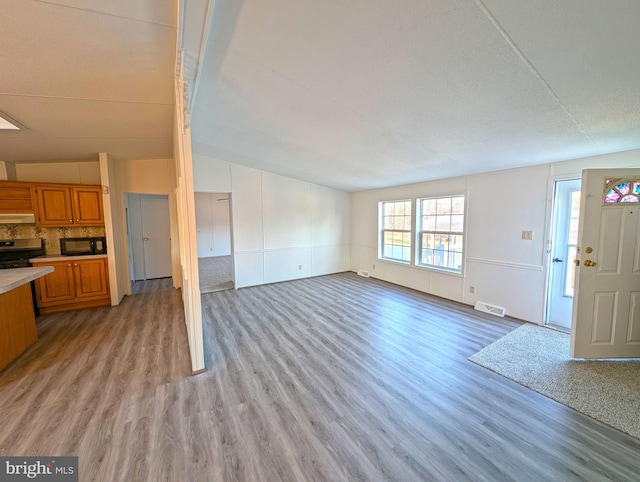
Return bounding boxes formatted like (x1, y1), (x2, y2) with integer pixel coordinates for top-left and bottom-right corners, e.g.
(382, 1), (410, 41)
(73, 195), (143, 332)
(0, 0), (640, 191)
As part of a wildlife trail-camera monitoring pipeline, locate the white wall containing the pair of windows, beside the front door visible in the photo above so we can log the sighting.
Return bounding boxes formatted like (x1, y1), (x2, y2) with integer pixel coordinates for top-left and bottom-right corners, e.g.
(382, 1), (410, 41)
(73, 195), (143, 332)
(351, 150), (640, 323)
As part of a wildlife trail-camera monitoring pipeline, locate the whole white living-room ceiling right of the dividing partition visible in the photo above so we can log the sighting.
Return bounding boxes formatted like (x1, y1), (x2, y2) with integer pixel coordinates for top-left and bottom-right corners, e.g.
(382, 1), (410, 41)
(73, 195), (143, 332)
(190, 0), (640, 191)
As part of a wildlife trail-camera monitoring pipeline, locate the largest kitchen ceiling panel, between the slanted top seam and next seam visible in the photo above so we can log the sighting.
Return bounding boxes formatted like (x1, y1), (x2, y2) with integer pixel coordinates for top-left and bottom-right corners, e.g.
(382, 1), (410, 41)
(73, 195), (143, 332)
(0, 0), (175, 104)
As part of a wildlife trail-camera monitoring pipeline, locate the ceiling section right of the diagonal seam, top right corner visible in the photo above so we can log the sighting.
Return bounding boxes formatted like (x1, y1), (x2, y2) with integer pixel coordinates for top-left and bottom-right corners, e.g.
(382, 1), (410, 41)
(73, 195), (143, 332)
(485, 0), (640, 140)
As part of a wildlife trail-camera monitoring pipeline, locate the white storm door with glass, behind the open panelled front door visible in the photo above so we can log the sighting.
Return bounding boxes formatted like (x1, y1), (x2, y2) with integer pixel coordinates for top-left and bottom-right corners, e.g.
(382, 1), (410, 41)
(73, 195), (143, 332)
(547, 179), (580, 330)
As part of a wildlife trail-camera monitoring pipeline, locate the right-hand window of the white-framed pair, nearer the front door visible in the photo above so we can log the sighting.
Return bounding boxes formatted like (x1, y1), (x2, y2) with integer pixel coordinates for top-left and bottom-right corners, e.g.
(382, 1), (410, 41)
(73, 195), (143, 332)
(416, 195), (464, 273)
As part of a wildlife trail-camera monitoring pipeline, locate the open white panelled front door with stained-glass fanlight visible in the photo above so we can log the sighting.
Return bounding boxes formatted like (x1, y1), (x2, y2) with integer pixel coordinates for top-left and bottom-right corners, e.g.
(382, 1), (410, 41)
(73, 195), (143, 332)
(571, 169), (640, 358)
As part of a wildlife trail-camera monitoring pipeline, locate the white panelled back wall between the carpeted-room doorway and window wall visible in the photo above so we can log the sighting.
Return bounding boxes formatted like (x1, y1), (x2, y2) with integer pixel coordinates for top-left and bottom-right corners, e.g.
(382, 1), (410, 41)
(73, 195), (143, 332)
(193, 154), (350, 288)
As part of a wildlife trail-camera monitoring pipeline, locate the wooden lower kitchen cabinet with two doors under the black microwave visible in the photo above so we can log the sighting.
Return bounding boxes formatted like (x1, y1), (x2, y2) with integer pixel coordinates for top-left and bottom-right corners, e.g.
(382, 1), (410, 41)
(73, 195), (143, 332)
(33, 258), (111, 315)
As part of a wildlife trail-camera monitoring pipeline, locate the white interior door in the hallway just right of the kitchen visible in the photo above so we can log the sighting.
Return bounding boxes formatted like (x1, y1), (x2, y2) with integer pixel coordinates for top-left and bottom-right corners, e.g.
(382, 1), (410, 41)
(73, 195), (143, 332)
(140, 196), (171, 279)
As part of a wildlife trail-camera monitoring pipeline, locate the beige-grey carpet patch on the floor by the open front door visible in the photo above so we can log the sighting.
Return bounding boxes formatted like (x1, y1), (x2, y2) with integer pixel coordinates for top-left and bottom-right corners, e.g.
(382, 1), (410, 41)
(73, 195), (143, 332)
(469, 324), (640, 438)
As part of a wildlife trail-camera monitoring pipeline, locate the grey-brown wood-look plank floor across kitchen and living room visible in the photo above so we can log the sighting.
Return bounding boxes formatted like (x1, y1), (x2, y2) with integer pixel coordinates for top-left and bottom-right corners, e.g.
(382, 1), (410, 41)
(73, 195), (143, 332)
(0, 273), (640, 482)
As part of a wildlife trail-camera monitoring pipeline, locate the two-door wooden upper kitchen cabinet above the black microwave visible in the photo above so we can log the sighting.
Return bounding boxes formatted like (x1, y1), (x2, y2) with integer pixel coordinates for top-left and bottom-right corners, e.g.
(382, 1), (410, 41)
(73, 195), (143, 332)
(35, 184), (104, 226)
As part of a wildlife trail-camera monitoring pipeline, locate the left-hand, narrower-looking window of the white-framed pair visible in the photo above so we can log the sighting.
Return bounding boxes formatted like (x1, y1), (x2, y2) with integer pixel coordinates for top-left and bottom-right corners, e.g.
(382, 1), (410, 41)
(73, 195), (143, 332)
(379, 199), (412, 263)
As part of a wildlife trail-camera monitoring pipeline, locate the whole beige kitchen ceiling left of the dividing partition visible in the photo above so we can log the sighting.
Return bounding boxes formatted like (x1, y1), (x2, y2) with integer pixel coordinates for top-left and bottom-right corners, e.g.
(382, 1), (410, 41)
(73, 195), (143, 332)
(0, 0), (177, 161)
